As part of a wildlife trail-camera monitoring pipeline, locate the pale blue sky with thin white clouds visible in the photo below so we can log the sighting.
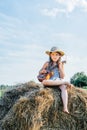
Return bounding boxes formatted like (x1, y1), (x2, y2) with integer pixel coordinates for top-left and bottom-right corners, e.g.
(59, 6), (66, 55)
(0, 0), (87, 85)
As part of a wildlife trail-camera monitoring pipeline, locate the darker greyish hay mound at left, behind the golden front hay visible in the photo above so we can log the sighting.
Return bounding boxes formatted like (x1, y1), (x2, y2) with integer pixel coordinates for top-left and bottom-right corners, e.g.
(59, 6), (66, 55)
(0, 81), (42, 120)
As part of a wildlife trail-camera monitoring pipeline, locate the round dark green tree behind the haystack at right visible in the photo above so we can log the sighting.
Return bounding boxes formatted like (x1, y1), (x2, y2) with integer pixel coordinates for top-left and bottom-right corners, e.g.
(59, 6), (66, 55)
(70, 72), (87, 87)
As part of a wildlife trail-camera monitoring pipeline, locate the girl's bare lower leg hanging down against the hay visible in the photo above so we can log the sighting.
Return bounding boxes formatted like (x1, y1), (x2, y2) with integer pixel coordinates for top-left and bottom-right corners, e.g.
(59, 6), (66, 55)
(59, 85), (69, 113)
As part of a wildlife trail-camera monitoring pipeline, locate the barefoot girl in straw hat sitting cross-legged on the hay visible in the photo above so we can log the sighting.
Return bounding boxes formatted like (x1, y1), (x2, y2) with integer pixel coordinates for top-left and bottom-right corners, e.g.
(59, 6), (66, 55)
(39, 47), (71, 113)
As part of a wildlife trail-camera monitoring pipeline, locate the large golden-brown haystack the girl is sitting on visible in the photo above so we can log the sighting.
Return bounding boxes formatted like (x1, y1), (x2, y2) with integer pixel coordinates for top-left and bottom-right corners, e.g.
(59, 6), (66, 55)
(0, 82), (87, 130)
